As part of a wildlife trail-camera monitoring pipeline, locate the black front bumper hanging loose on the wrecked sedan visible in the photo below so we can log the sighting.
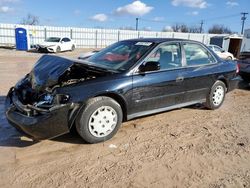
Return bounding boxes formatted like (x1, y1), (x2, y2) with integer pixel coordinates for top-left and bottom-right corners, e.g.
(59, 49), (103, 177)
(5, 89), (70, 140)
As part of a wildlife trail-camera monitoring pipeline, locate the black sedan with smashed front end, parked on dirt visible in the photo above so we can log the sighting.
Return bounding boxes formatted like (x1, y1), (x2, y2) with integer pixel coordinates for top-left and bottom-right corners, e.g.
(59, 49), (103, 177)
(6, 39), (239, 143)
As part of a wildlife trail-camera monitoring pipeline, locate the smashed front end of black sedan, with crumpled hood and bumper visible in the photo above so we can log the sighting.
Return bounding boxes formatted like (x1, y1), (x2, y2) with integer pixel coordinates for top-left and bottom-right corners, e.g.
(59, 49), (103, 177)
(6, 55), (108, 140)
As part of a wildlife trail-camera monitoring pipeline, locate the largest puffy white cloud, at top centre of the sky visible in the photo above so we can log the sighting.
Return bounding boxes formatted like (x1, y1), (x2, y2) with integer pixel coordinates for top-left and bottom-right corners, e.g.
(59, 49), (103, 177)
(115, 1), (154, 16)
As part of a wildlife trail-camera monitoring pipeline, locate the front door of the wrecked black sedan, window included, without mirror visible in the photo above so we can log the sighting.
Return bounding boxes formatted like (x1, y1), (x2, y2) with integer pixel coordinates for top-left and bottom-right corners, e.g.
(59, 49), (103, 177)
(131, 42), (184, 114)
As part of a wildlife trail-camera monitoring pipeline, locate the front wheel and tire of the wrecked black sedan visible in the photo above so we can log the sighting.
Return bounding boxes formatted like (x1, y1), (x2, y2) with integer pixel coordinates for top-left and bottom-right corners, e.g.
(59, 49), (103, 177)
(76, 97), (123, 144)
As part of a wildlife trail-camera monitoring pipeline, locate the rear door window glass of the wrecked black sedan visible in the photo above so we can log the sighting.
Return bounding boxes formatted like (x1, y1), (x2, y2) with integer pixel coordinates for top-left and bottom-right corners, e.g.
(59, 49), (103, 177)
(183, 43), (215, 66)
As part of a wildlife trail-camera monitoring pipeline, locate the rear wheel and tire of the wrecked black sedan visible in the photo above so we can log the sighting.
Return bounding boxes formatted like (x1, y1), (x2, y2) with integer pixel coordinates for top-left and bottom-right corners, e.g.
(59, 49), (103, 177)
(205, 80), (227, 110)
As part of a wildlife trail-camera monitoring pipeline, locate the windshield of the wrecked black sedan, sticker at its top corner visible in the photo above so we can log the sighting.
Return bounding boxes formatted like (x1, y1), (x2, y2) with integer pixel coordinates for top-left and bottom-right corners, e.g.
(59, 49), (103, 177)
(87, 41), (153, 71)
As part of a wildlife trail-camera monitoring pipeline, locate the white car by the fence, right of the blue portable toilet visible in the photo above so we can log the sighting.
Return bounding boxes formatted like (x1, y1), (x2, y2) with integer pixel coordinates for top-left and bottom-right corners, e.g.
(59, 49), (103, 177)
(37, 37), (76, 53)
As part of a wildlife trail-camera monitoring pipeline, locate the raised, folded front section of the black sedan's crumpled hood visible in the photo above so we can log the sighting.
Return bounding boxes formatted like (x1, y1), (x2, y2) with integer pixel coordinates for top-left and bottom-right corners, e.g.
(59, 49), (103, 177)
(30, 55), (75, 91)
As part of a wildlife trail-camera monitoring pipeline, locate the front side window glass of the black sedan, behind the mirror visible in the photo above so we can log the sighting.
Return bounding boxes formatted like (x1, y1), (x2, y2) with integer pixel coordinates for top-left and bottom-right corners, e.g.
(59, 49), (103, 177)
(147, 43), (182, 70)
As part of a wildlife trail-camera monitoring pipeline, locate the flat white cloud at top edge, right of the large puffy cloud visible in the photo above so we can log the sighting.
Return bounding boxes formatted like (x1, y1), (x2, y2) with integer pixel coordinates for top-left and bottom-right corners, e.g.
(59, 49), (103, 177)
(172, 0), (208, 9)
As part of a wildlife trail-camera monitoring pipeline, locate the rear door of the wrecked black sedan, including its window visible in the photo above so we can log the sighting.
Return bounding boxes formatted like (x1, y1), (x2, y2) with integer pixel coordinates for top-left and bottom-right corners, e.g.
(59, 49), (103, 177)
(182, 42), (218, 102)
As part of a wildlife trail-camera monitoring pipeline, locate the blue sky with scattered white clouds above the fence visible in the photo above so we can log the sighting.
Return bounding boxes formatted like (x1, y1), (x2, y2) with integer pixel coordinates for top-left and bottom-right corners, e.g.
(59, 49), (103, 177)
(0, 0), (250, 32)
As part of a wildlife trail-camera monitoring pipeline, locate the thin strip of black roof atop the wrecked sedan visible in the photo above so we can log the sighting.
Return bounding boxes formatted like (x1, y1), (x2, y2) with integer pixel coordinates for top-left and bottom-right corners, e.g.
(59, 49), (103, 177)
(124, 38), (200, 43)
